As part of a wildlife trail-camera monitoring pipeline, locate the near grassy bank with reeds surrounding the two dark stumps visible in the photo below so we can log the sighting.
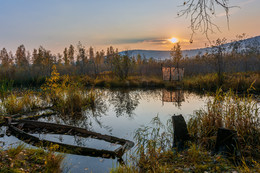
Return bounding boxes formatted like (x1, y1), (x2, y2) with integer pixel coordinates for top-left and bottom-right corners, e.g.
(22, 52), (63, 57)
(111, 90), (260, 173)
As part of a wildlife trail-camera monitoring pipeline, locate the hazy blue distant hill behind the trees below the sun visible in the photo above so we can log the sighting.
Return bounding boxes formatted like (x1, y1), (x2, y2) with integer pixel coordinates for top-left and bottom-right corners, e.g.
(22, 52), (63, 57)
(120, 36), (260, 60)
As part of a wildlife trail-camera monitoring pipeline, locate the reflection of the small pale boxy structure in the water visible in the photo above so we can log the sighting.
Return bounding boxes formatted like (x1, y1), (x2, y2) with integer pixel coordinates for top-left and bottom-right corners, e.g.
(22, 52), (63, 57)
(162, 90), (185, 107)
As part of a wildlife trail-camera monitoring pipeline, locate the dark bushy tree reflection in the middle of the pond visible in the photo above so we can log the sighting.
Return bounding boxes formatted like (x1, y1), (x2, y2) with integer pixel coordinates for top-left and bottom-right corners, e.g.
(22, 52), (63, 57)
(108, 90), (140, 117)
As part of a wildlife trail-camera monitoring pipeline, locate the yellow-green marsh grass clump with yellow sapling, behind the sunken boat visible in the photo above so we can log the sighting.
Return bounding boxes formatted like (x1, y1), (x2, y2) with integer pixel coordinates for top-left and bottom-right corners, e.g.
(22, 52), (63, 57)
(42, 66), (96, 116)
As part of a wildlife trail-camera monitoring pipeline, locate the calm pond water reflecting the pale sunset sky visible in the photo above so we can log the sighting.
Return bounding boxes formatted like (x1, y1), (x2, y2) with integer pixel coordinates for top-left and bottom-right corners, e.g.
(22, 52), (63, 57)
(0, 89), (207, 173)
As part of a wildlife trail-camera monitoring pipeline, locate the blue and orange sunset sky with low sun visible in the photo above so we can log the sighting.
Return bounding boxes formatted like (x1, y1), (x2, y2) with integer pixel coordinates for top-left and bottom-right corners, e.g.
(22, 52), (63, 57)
(0, 0), (260, 53)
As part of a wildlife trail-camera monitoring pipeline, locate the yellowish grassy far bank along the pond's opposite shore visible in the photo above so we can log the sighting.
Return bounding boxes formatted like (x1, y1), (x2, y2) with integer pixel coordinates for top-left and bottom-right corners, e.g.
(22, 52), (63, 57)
(77, 73), (260, 93)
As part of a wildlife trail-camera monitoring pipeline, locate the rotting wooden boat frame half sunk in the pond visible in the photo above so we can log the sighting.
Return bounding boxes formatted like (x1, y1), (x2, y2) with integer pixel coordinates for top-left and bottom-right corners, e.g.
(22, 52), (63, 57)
(7, 118), (134, 158)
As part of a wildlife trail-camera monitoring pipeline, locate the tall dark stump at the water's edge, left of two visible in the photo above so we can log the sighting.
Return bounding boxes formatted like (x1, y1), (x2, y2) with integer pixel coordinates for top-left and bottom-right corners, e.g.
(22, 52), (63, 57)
(172, 115), (190, 151)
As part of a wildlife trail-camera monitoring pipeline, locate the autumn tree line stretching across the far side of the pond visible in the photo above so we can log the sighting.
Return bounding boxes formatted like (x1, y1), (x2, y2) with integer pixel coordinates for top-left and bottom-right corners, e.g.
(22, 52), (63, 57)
(0, 35), (260, 85)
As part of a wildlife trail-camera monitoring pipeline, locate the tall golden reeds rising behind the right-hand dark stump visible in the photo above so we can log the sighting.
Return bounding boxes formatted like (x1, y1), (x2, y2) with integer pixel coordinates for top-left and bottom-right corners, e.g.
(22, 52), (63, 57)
(188, 89), (260, 159)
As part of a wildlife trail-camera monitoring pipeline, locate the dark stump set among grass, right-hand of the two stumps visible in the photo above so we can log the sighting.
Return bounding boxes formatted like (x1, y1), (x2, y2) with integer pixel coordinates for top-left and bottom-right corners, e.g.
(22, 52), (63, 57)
(214, 128), (241, 165)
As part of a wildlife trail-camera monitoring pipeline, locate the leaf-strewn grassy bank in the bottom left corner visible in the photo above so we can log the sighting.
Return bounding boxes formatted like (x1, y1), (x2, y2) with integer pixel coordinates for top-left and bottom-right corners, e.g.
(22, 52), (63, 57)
(0, 145), (64, 173)
